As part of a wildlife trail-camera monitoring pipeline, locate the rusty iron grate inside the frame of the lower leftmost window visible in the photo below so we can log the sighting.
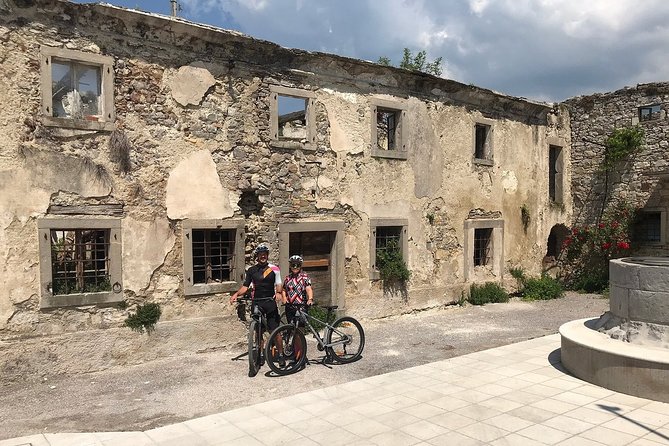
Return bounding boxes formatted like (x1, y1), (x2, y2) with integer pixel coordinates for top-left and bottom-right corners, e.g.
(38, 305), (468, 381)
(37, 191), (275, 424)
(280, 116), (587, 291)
(51, 229), (111, 296)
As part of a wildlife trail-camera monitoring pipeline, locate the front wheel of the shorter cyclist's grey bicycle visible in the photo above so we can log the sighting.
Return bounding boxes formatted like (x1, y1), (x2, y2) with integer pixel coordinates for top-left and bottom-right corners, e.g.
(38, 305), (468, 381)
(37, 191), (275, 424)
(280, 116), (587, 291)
(265, 324), (307, 375)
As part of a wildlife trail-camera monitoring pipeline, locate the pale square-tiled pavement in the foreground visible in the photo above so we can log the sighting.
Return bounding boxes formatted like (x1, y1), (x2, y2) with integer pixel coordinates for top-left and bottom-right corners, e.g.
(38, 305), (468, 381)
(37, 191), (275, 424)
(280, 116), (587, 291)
(0, 334), (669, 446)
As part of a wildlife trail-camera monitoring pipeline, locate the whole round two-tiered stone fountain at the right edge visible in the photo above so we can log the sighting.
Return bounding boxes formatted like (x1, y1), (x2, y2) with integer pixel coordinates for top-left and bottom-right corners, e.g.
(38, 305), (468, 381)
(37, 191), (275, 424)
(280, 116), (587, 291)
(560, 257), (669, 402)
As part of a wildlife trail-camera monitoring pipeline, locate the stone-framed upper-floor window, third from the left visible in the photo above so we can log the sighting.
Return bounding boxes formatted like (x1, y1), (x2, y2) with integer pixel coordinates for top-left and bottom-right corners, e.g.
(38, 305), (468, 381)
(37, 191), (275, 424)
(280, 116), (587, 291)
(371, 98), (407, 159)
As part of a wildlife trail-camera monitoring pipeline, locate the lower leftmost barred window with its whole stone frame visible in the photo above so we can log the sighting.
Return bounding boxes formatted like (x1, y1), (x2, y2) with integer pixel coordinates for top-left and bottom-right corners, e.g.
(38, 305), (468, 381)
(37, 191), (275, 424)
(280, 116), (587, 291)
(38, 218), (123, 308)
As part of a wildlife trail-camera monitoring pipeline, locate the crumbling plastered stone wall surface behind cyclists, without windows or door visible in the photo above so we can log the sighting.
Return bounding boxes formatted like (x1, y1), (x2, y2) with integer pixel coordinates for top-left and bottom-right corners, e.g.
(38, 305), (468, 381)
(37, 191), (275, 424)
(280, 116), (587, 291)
(0, 0), (571, 334)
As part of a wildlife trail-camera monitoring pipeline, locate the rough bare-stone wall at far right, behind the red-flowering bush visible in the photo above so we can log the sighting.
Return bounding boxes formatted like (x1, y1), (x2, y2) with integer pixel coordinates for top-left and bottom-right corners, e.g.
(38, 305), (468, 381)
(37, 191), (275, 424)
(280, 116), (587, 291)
(564, 82), (669, 255)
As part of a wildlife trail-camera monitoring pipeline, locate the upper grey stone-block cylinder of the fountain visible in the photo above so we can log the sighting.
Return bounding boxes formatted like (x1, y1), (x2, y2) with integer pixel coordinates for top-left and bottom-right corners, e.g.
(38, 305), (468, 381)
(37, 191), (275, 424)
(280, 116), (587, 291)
(609, 257), (669, 325)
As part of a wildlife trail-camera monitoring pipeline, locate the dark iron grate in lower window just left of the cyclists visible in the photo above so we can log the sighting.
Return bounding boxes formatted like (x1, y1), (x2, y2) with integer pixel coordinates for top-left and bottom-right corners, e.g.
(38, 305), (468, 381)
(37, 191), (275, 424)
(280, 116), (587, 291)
(192, 229), (235, 283)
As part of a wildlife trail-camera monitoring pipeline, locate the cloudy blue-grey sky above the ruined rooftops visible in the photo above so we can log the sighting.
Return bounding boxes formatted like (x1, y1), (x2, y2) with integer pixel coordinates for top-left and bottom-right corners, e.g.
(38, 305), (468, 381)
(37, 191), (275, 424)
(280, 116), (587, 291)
(76, 0), (669, 102)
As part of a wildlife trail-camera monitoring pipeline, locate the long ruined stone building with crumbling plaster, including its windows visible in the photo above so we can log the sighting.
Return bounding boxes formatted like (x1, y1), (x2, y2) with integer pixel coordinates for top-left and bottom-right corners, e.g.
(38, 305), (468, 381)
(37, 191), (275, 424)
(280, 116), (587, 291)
(0, 0), (572, 335)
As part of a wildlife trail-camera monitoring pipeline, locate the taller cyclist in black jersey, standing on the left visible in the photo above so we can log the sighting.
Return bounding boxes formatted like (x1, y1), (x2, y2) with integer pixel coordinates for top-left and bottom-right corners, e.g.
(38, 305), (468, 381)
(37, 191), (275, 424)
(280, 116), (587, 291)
(230, 245), (283, 333)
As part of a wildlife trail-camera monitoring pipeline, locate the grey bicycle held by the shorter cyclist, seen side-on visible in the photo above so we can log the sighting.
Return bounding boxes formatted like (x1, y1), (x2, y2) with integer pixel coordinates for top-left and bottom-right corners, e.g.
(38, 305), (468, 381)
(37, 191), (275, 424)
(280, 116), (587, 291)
(265, 304), (365, 375)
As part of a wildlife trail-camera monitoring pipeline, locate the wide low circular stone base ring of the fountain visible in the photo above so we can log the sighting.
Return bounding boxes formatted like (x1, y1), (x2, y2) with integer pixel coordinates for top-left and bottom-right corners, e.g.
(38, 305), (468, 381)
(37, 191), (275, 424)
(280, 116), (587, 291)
(560, 319), (669, 403)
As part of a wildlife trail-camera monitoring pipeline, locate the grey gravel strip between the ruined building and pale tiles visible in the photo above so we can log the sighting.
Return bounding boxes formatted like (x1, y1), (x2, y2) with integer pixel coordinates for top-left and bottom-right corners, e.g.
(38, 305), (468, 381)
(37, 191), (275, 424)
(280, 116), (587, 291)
(0, 293), (609, 440)
